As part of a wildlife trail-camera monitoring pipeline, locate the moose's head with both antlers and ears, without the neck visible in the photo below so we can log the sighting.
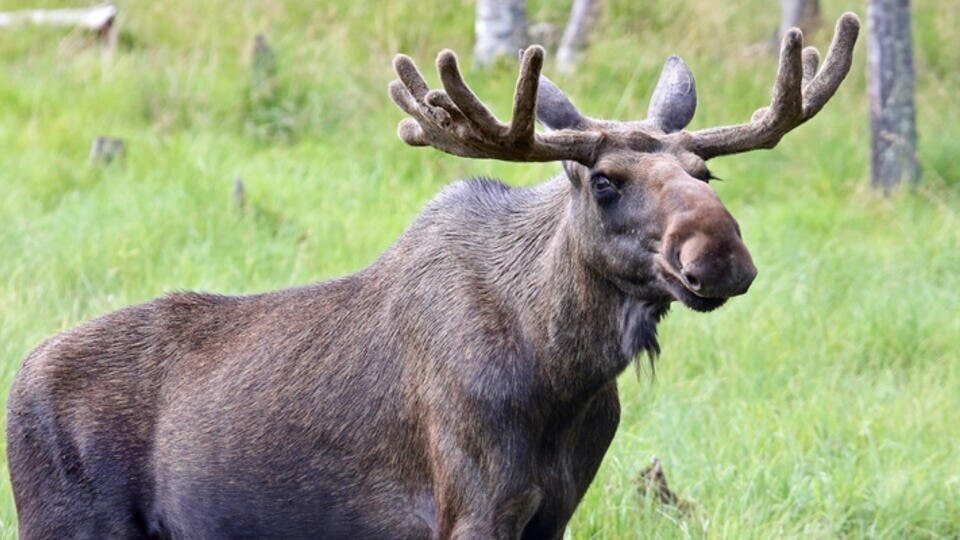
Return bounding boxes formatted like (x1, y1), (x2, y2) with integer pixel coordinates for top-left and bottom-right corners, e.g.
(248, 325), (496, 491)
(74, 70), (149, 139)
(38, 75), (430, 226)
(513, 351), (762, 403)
(390, 13), (859, 311)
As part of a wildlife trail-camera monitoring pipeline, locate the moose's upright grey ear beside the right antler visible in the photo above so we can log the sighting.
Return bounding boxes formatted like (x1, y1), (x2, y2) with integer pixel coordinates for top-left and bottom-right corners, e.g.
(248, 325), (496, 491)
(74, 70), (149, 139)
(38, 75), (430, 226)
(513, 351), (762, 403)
(647, 55), (697, 133)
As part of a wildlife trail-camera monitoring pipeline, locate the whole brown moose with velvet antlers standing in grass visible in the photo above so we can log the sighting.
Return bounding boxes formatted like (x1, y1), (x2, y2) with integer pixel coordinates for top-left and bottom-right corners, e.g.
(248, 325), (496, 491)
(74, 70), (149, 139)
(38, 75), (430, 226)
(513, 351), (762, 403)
(7, 13), (859, 539)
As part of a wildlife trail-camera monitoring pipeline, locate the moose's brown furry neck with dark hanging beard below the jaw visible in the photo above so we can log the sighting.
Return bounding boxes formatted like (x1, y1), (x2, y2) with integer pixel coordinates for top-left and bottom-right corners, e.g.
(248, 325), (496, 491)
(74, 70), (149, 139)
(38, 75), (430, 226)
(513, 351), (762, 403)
(474, 176), (667, 401)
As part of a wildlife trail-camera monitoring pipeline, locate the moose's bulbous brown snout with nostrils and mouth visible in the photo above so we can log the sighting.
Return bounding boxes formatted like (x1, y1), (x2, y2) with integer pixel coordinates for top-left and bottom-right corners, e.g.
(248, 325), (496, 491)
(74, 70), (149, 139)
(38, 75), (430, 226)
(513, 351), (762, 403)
(668, 218), (757, 298)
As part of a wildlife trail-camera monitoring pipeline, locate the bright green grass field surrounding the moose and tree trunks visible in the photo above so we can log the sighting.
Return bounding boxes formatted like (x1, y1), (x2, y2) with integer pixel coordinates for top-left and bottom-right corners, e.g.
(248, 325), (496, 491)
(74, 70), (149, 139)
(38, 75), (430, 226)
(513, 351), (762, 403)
(0, 0), (960, 538)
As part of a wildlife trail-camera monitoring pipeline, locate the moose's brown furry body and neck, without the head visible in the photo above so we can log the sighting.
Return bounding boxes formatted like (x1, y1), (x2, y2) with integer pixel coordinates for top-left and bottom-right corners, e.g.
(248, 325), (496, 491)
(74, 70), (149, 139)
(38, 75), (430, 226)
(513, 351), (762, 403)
(8, 177), (665, 538)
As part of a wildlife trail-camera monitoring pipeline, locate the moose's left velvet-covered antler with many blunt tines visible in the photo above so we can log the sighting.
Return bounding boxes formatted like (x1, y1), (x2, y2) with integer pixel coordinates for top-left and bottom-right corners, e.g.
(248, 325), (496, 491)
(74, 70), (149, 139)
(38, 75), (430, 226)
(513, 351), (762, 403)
(390, 46), (601, 162)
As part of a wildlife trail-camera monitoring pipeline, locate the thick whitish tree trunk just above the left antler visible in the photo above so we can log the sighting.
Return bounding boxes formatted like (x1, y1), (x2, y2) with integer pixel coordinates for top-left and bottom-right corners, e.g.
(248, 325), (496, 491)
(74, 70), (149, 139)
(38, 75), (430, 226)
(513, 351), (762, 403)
(473, 0), (527, 67)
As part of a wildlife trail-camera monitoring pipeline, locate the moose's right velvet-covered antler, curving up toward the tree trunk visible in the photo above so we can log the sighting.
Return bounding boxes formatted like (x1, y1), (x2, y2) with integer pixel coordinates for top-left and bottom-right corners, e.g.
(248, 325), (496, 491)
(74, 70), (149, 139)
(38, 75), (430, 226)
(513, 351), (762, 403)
(685, 13), (860, 159)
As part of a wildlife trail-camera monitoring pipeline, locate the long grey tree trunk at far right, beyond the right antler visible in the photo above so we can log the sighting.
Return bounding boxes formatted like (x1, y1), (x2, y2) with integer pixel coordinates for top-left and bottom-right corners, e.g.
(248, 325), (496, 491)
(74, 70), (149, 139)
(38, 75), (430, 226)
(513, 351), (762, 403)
(867, 0), (920, 192)
